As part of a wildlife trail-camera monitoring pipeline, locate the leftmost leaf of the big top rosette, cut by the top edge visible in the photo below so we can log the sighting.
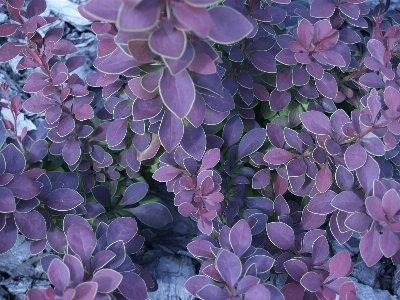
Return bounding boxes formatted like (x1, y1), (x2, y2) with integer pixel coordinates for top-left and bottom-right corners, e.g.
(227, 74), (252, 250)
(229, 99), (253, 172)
(83, 0), (122, 23)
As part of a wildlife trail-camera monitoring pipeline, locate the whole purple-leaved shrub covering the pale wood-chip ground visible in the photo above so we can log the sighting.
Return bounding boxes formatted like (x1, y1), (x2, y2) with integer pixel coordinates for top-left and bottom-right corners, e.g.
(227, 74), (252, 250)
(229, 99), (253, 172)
(0, 0), (400, 300)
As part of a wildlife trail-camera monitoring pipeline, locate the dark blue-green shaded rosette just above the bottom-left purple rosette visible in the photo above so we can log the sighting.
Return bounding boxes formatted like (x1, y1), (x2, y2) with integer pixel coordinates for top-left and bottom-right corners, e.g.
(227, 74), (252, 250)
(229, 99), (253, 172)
(91, 182), (172, 227)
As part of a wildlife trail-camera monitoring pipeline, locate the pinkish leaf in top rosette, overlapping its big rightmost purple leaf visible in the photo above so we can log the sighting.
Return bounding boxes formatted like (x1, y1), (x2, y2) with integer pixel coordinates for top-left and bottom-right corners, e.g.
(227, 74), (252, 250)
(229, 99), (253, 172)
(173, 2), (213, 38)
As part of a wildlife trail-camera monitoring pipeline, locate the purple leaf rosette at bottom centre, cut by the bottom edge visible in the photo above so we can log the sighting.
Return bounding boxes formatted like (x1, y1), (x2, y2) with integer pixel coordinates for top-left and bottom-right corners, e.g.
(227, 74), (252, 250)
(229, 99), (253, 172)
(185, 220), (284, 300)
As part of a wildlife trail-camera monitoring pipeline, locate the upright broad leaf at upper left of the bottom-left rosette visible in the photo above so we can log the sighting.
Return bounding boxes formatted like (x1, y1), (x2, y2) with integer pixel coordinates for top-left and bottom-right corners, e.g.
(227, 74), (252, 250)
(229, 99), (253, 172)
(67, 223), (97, 265)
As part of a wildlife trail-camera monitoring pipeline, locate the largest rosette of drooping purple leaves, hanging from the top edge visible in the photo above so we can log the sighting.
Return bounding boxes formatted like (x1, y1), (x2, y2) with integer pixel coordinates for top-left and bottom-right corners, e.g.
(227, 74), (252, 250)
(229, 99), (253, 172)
(81, 0), (253, 120)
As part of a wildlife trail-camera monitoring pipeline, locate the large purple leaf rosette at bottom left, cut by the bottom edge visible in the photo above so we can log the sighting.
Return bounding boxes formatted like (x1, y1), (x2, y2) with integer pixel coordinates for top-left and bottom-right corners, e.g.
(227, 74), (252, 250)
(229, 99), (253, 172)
(27, 215), (155, 300)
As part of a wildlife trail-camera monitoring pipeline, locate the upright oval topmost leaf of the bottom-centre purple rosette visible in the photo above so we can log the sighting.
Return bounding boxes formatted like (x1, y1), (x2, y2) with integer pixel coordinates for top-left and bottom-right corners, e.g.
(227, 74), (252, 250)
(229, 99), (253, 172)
(229, 220), (252, 257)
